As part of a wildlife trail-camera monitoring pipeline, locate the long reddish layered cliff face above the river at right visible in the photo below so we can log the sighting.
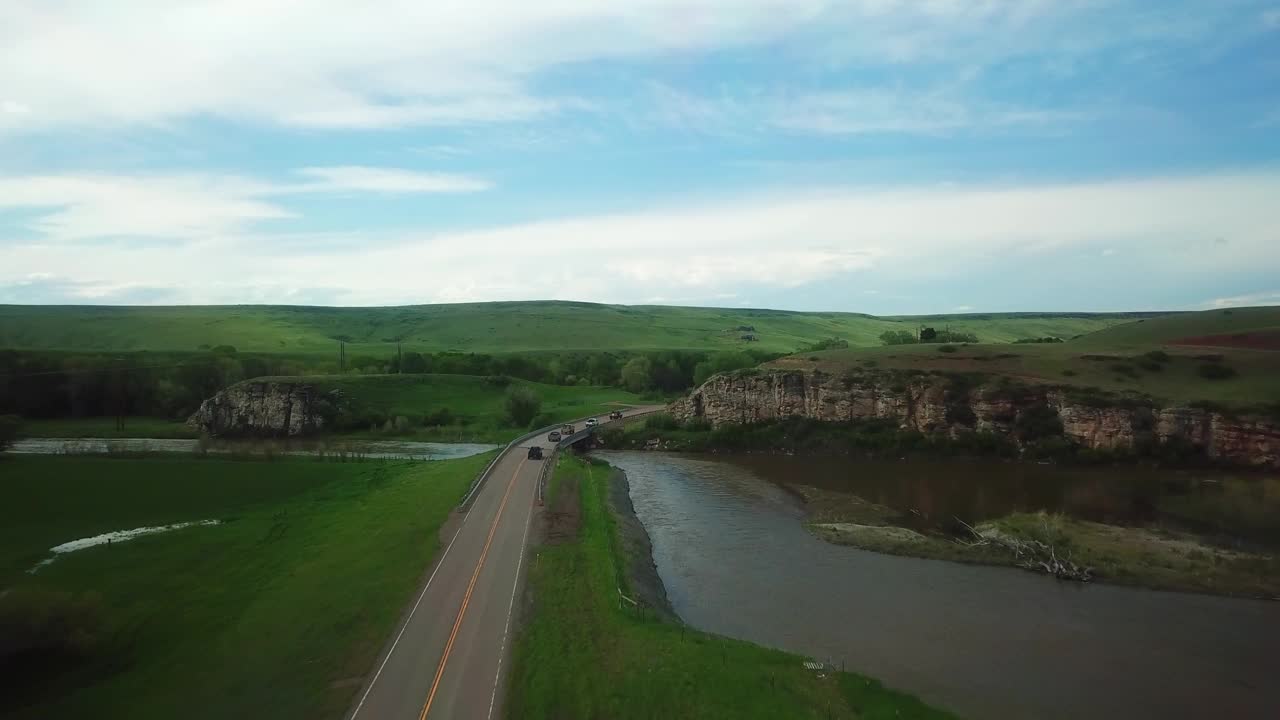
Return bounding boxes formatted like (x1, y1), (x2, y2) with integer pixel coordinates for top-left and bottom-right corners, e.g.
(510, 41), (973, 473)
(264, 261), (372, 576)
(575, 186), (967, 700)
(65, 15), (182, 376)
(669, 370), (1280, 469)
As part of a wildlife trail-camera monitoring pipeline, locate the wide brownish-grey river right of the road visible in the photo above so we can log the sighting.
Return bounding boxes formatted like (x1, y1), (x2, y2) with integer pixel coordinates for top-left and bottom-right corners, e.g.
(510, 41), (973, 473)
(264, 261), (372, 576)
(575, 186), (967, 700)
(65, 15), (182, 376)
(598, 451), (1280, 720)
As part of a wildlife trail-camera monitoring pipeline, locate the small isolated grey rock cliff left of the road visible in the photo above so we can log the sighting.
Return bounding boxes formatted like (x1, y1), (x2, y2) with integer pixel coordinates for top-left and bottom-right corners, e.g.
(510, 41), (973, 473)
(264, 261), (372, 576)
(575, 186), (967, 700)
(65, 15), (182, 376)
(187, 380), (340, 437)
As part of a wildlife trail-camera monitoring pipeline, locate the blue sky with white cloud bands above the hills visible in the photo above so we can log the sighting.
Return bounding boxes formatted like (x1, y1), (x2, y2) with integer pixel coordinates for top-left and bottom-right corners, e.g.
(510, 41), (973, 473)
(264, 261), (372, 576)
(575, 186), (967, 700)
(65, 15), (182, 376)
(0, 0), (1280, 314)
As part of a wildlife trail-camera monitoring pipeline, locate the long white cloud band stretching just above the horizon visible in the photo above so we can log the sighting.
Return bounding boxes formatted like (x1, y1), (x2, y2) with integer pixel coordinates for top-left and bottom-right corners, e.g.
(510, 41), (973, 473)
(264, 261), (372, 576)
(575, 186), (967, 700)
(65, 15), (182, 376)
(0, 173), (1280, 305)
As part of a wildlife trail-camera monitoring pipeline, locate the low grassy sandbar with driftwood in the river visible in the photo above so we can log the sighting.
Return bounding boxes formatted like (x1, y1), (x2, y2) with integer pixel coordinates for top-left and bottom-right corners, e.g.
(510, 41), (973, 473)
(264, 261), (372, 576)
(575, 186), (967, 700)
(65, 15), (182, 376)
(788, 484), (1280, 598)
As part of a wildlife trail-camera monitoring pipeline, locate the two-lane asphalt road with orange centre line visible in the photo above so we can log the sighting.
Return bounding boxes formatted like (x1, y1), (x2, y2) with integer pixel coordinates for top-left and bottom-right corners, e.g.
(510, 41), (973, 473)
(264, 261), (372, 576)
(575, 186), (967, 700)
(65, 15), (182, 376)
(348, 407), (653, 720)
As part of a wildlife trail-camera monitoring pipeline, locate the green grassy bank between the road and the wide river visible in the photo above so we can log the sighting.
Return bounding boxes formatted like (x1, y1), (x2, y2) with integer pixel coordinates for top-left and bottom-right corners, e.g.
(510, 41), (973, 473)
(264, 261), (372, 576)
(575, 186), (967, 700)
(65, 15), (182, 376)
(507, 457), (951, 719)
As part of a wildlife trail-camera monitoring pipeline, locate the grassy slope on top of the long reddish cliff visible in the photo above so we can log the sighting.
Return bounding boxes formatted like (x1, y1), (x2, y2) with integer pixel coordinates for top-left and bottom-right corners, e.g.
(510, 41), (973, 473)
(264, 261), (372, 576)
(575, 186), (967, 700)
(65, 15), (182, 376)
(769, 307), (1280, 410)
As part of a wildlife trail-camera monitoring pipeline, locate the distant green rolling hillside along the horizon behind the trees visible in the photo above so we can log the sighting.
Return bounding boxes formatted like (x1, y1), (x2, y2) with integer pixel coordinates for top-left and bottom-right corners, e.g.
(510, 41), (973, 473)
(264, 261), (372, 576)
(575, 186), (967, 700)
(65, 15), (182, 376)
(0, 302), (1143, 356)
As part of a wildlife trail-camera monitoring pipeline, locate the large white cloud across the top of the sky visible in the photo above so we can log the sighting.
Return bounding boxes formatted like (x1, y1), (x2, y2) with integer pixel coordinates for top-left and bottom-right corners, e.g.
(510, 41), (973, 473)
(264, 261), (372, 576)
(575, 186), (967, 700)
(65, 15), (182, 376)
(0, 0), (1228, 132)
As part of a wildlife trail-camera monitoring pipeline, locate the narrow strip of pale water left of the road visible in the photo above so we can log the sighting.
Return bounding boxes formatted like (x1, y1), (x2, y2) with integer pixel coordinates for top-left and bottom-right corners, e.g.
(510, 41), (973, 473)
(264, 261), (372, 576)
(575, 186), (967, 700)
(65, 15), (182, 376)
(8, 438), (498, 460)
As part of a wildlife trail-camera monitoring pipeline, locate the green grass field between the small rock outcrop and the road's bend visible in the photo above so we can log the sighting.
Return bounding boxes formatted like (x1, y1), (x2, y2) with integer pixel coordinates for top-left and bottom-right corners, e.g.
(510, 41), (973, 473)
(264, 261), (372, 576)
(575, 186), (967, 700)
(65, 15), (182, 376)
(271, 374), (645, 442)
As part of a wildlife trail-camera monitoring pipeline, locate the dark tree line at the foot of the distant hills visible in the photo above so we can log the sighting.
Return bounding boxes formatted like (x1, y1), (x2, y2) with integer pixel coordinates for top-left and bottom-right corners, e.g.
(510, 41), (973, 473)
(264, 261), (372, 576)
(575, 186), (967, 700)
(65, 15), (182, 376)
(0, 346), (780, 418)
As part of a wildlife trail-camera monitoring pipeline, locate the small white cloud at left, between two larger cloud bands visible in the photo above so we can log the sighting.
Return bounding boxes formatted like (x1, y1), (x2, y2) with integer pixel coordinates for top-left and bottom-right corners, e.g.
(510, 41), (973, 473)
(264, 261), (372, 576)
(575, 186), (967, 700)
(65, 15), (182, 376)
(0, 165), (490, 241)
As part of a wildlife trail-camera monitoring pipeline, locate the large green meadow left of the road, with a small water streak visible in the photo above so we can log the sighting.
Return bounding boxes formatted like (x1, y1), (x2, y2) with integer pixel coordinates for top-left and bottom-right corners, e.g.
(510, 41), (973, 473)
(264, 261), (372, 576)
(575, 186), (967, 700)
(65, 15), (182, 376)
(0, 455), (492, 719)
